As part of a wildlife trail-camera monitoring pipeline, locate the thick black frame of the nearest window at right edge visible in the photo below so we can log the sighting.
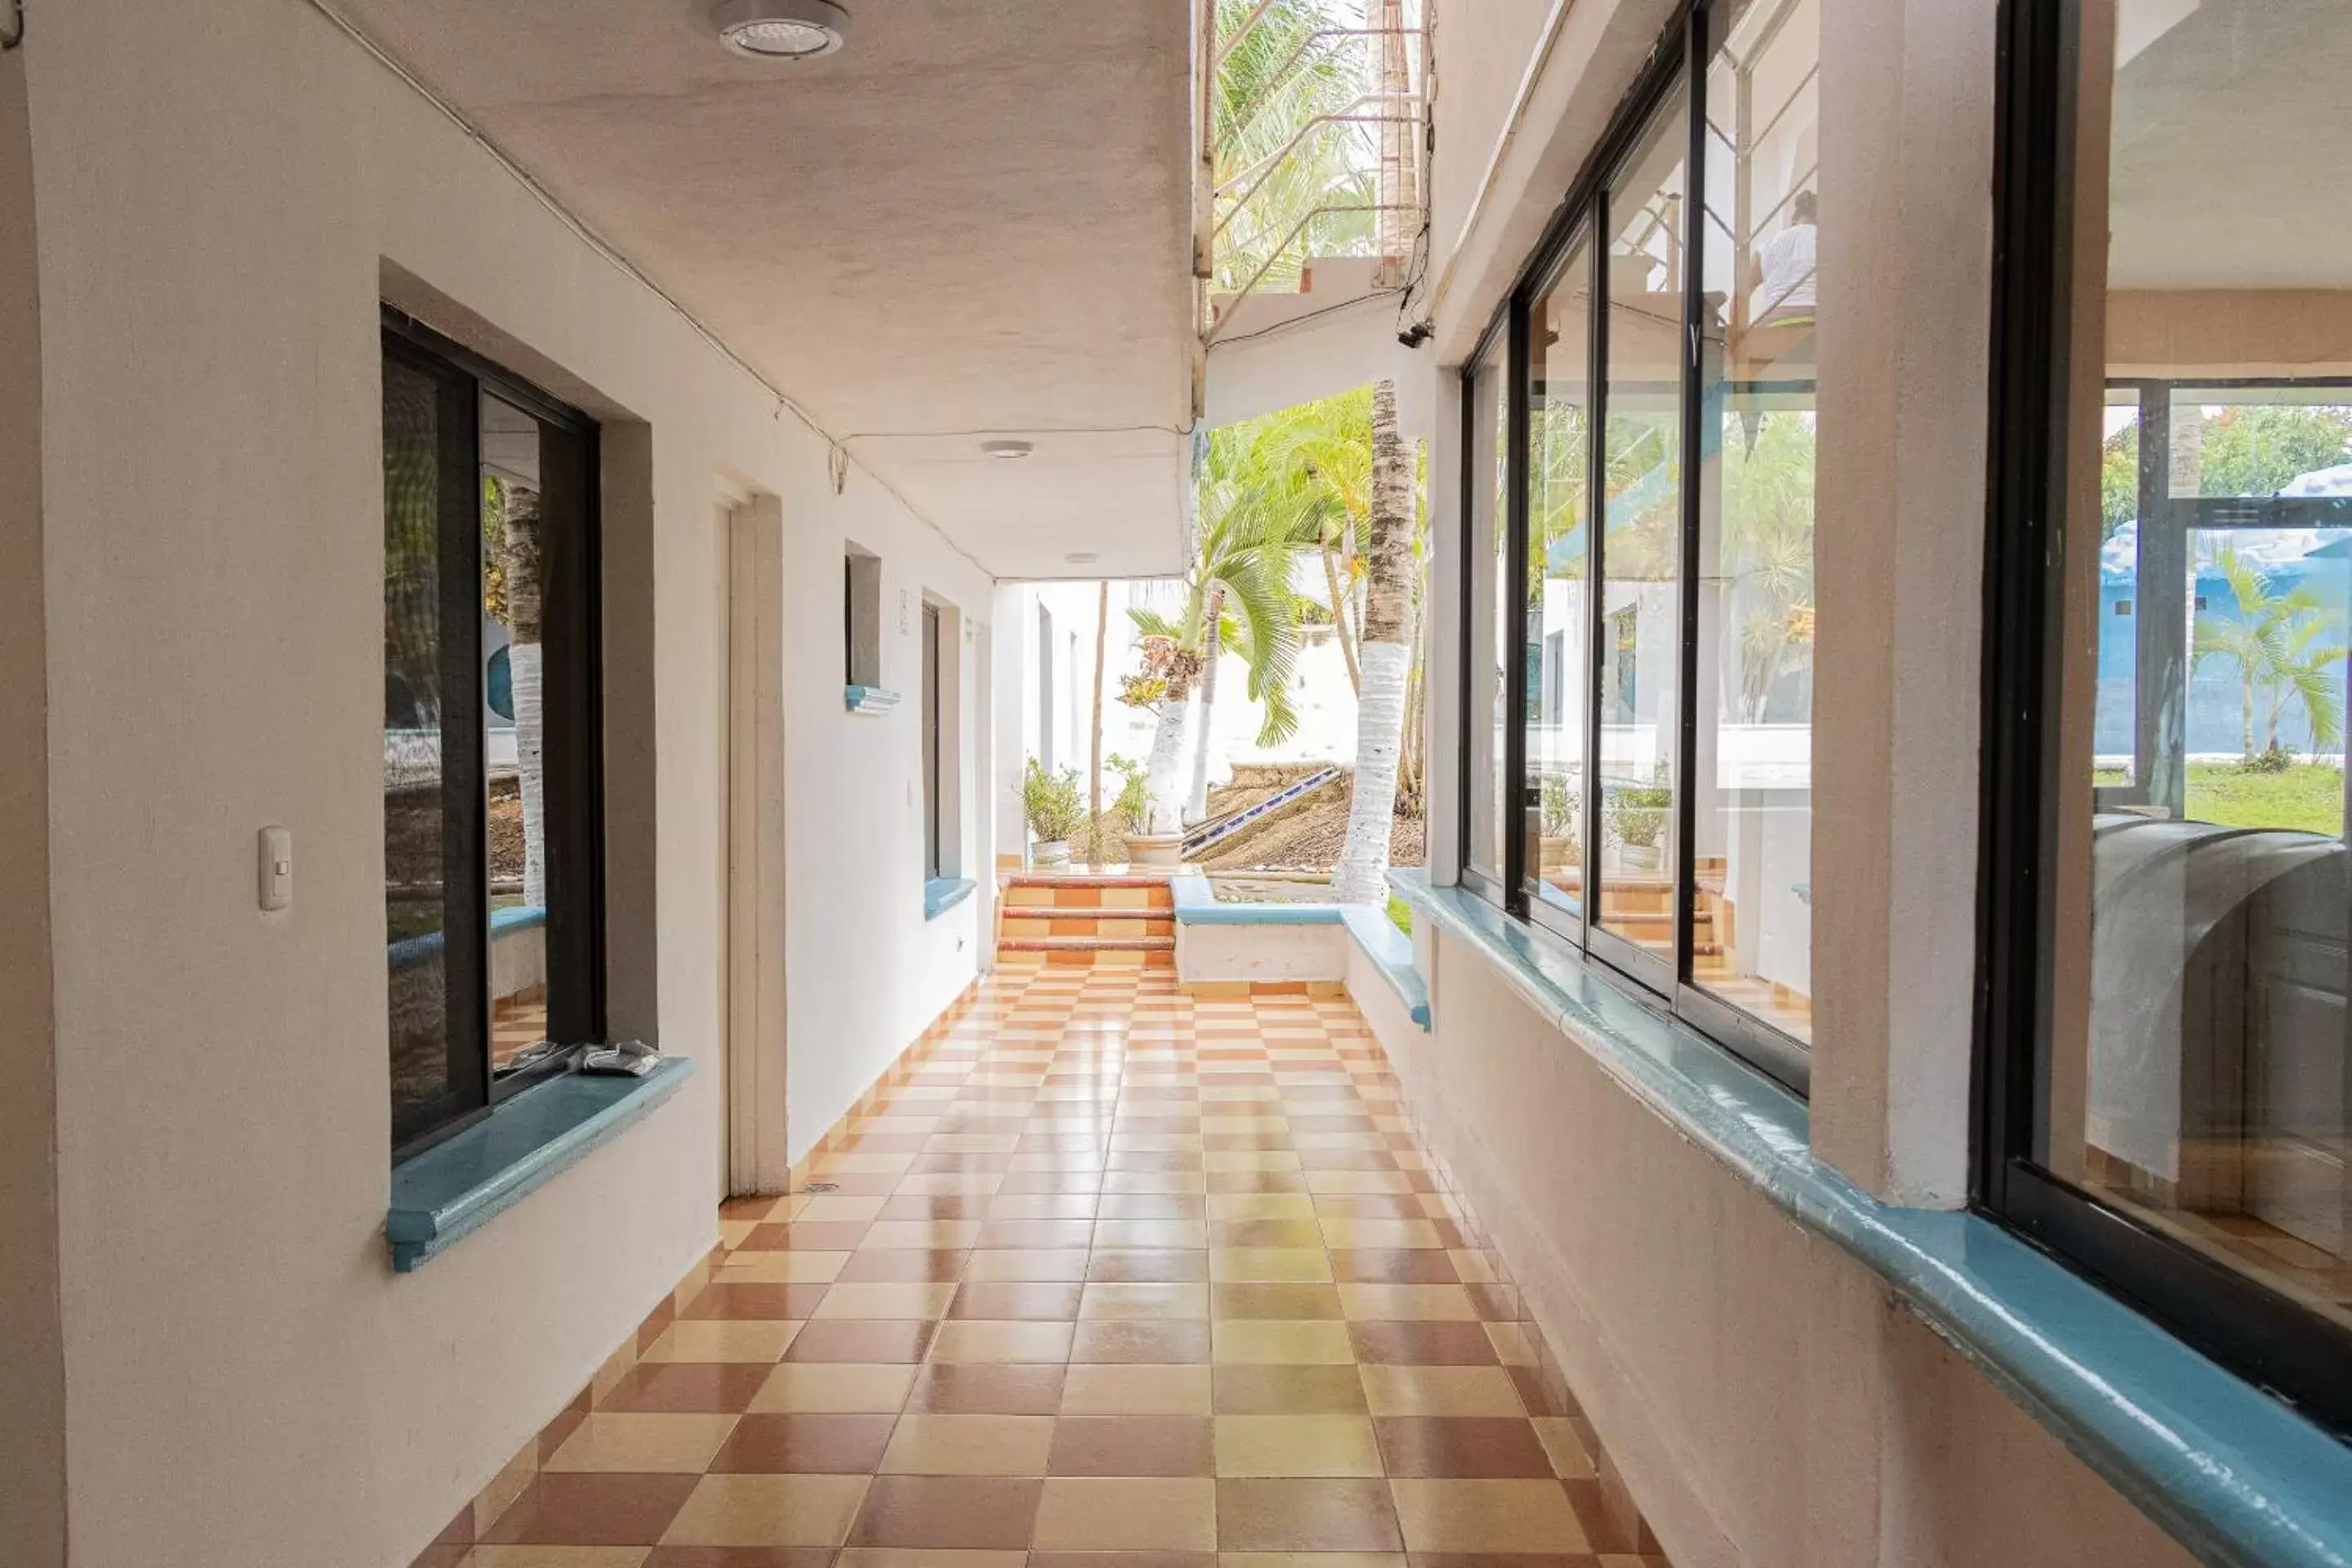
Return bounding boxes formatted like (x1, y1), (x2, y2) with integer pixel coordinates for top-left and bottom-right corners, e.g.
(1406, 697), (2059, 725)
(1971, 0), (2352, 1439)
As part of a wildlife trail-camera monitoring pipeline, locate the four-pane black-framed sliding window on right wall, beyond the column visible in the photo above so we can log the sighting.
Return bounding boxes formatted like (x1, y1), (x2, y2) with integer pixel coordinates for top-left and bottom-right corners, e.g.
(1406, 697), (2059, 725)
(1463, 0), (1820, 1089)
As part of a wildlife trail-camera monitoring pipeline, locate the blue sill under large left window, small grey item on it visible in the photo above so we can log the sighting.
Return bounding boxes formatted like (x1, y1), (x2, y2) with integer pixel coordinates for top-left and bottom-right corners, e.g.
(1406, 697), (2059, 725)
(383, 1055), (694, 1274)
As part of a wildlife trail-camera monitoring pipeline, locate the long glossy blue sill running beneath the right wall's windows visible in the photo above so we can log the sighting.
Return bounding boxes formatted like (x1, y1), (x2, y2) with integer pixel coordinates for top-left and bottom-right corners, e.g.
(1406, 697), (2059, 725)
(1390, 870), (2352, 1568)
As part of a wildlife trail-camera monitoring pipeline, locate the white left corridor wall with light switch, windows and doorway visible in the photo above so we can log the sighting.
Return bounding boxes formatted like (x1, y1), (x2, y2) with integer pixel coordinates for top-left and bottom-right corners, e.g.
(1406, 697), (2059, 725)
(11, 0), (988, 1568)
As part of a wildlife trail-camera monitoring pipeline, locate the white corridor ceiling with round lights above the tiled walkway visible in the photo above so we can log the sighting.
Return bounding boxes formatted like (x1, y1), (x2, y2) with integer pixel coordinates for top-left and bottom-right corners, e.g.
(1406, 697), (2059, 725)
(339, 0), (1192, 578)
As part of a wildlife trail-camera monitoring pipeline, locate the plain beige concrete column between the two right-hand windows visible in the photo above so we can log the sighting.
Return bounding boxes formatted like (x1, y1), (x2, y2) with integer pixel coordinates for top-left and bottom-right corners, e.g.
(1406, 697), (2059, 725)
(1813, 0), (1999, 1206)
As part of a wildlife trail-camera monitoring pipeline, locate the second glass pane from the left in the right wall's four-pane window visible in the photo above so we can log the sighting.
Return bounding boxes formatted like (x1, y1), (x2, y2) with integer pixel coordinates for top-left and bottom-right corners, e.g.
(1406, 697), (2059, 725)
(1524, 242), (1592, 924)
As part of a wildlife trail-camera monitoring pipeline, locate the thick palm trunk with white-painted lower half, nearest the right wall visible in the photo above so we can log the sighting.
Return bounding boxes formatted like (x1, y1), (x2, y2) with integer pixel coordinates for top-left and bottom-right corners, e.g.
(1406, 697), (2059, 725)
(1331, 381), (1414, 902)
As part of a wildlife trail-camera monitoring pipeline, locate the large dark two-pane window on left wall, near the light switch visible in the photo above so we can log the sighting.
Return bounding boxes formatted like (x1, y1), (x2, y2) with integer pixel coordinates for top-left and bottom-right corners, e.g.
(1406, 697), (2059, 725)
(383, 313), (604, 1156)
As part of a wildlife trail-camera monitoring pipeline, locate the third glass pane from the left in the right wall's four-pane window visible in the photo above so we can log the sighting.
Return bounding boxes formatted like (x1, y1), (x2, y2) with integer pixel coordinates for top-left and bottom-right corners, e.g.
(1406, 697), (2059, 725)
(1597, 91), (1689, 955)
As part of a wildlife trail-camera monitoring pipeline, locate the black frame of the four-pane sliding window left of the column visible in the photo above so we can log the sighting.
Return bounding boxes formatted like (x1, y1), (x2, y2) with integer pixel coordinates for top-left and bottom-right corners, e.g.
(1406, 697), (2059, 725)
(1456, 0), (1811, 1095)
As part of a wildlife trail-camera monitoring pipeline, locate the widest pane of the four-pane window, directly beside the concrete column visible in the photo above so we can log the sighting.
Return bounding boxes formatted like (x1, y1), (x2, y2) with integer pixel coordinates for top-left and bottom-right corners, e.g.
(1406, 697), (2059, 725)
(1689, 0), (1820, 1039)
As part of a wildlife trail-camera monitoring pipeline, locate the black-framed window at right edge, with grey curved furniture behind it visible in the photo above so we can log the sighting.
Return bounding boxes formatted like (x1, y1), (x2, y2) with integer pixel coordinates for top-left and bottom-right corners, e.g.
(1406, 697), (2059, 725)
(1980, 0), (2352, 1434)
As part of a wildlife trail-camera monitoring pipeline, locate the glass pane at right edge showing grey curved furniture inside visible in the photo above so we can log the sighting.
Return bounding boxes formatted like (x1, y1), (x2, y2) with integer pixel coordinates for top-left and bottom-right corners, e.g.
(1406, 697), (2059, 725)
(2037, 0), (2352, 1328)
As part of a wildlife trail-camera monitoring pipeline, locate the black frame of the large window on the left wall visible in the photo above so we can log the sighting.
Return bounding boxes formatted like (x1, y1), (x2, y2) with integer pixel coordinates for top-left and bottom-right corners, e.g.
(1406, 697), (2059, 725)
(379, 305), (607, 1164)
